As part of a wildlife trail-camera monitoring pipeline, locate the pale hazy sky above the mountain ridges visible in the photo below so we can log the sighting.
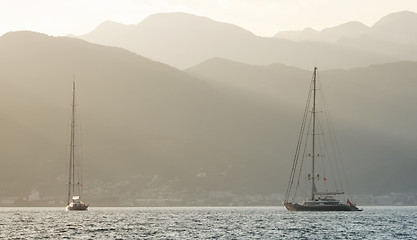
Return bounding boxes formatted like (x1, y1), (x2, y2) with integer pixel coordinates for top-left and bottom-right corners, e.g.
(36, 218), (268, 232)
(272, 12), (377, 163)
(0, 0), (417, 36)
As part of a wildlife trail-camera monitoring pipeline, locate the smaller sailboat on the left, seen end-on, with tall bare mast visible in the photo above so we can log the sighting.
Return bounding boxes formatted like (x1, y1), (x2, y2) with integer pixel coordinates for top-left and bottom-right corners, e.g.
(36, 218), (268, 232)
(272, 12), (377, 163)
(66, 82), (88, 211)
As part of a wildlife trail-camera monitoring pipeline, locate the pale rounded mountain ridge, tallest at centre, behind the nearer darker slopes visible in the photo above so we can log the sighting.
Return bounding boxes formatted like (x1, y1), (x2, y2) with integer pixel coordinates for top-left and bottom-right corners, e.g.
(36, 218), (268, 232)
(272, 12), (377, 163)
(80, 13), (395, 69)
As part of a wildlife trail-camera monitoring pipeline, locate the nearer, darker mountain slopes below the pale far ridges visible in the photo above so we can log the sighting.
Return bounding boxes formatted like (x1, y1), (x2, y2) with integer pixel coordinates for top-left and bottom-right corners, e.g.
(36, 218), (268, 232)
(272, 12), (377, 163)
(0, 30), (417, 204)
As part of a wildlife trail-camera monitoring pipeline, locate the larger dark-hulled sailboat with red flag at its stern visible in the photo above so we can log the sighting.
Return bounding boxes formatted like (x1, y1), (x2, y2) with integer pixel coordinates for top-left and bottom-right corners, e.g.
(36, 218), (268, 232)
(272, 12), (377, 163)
(283, 67), (361, 211)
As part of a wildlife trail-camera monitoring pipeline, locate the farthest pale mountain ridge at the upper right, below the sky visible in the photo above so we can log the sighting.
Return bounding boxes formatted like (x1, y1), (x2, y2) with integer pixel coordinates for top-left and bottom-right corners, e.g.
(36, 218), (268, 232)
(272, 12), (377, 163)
(275, 11), (417, 61)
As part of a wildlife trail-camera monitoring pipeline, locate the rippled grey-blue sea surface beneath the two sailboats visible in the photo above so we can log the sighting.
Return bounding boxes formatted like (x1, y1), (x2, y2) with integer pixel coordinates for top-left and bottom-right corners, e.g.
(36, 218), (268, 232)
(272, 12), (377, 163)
(0, 207), (417, 239)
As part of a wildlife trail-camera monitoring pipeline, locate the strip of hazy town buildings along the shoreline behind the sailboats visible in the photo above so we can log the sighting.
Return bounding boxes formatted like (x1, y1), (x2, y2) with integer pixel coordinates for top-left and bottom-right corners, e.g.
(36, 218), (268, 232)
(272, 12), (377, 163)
(0, 189), (417, 207)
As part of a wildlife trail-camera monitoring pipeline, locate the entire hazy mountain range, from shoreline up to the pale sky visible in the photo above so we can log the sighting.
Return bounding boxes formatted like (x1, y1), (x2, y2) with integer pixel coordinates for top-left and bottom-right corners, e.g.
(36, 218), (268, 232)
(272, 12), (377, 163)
(0, 9), (417, 205)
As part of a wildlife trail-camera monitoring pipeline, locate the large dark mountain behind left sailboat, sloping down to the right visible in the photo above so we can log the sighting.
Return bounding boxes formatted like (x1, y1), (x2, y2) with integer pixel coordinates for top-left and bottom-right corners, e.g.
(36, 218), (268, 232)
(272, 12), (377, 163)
(0, 32), (302, 202)
